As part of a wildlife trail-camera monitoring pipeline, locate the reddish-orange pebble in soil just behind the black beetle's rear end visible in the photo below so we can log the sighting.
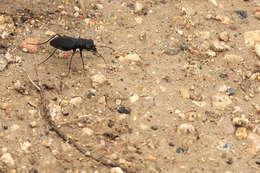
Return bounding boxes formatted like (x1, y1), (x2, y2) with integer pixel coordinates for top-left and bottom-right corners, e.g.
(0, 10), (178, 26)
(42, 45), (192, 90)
(19, 38), (38, 53)
